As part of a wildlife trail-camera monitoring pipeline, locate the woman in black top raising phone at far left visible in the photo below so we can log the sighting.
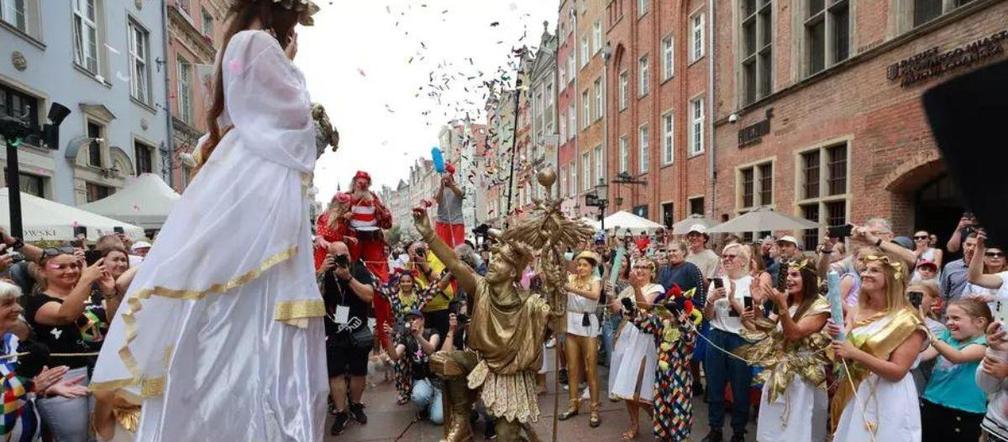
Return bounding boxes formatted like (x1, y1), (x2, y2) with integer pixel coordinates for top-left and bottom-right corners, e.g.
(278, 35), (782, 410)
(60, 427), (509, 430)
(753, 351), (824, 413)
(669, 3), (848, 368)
(24, 247), (120, 442)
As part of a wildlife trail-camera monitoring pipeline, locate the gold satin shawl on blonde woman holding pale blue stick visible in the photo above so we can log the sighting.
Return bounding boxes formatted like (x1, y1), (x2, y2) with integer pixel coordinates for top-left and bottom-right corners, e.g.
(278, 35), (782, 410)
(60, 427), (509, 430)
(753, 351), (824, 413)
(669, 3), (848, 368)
(830, 308), (923, 431)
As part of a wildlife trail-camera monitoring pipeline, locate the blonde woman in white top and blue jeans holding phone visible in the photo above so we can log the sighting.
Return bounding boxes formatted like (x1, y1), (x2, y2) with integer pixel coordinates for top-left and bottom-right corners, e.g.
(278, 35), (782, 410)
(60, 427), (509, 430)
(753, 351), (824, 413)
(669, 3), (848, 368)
(704, 242), (753, 442)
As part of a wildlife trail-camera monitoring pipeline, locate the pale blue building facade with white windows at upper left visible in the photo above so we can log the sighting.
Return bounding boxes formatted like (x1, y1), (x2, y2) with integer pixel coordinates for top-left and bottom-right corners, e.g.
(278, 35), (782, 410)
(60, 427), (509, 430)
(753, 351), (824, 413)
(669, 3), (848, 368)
(0, 0), (169, 205)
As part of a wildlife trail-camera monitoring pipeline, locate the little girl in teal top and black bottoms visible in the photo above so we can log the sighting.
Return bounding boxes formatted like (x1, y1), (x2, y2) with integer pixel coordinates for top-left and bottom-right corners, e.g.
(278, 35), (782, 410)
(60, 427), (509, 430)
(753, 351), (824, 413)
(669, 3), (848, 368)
(920, 298), (993, 442)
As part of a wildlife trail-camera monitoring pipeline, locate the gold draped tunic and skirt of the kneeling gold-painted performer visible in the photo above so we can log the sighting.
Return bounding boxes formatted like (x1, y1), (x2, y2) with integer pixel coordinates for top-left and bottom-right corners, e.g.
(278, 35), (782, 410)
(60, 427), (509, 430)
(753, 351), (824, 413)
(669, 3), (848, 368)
(468, 278), (549, 423)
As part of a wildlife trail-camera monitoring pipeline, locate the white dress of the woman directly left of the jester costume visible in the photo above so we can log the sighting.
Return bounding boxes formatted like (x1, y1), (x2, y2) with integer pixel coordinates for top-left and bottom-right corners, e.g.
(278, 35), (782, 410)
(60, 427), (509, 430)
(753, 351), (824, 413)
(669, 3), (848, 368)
(609, 284), (665, 403)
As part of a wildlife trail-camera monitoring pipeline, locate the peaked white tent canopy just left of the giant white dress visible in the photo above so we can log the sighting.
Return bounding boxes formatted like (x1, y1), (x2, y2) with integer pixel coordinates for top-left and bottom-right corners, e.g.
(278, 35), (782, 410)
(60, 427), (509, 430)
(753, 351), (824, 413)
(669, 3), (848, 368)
(81, 174), (181, 229)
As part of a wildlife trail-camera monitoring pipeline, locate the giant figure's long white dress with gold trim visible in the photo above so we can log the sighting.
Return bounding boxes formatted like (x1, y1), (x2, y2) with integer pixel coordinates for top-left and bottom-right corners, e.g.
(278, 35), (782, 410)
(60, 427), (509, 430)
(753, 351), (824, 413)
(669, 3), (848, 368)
(91, 31), (329, 441)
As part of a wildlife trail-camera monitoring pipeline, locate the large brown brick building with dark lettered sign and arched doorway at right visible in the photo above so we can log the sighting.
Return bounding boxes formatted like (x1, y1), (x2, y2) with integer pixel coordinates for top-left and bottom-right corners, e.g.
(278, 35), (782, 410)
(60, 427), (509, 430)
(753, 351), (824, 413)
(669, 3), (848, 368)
(709, 0), (1008, 247)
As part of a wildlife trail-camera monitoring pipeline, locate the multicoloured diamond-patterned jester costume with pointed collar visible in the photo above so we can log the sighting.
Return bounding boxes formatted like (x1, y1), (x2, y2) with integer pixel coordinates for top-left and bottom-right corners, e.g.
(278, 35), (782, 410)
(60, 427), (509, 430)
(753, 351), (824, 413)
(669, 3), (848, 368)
(632, 286), (699, 442)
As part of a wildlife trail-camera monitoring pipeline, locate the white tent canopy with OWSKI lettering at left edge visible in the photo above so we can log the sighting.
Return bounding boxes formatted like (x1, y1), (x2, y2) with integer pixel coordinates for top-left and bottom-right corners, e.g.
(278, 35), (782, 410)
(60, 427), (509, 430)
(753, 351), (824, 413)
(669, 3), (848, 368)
(0, 188), (144, 241)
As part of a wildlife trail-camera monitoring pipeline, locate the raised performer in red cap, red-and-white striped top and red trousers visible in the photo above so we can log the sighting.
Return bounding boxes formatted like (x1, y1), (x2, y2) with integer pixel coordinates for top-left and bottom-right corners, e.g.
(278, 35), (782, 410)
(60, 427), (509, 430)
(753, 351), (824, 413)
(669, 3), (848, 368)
(349, 171), (392, 345)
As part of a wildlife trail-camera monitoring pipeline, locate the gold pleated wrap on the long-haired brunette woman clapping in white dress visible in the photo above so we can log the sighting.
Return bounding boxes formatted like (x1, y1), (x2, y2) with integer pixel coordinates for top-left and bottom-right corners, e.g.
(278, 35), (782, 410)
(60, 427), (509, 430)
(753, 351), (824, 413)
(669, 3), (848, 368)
(735, 296), (830, 403)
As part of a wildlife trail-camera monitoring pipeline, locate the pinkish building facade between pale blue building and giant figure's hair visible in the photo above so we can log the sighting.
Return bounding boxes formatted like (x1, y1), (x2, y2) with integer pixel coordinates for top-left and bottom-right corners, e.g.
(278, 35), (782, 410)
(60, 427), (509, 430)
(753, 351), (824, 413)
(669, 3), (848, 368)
(165, 0), (228, 192)
